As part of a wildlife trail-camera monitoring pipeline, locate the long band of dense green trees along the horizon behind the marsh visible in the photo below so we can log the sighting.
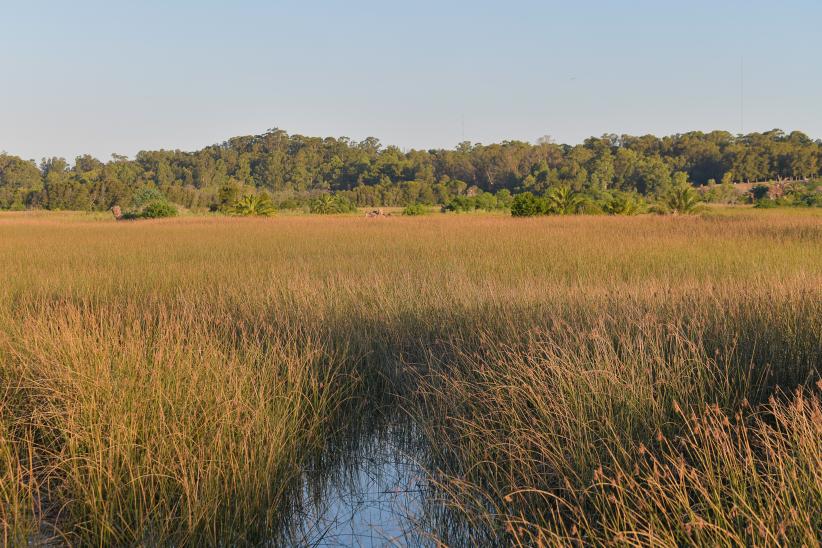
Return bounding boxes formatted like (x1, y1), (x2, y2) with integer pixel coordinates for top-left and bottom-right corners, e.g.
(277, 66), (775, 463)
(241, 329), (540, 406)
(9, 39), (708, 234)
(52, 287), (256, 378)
(0, 129), (822, 210)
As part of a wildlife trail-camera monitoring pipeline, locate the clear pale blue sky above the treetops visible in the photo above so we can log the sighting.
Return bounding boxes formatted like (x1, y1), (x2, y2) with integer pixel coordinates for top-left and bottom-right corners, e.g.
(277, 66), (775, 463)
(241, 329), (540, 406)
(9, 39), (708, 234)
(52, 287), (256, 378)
(0, 0), (822, 160)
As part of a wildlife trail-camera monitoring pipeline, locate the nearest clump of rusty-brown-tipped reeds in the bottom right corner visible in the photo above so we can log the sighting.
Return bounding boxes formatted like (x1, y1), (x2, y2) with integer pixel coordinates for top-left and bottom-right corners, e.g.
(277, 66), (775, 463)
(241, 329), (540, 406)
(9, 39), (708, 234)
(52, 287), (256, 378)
(492, 390), (822, 546)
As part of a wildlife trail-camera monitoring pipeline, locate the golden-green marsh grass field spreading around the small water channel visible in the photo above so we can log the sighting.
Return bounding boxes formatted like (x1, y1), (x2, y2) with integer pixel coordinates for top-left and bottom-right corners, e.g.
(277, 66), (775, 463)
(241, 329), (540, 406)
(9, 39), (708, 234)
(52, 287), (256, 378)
(0, 209), (822, 546)
